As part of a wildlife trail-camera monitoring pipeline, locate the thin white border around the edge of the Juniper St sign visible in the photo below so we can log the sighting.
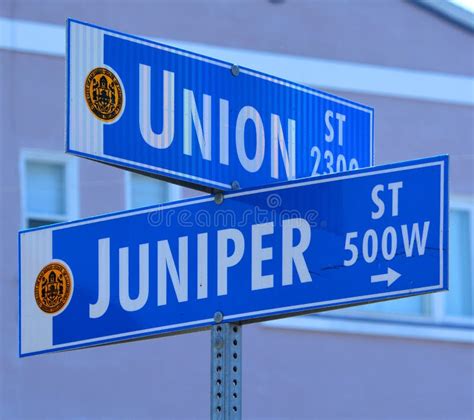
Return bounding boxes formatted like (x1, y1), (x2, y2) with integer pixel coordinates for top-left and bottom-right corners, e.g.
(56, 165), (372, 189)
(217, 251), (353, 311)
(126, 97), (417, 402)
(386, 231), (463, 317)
(18, 156), (449, 356)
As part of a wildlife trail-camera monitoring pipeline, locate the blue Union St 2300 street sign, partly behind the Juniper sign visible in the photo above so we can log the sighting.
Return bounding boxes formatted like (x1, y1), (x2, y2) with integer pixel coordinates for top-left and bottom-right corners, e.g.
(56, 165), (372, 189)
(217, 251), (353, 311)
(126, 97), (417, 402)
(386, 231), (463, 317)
(66, 20), (373, 191)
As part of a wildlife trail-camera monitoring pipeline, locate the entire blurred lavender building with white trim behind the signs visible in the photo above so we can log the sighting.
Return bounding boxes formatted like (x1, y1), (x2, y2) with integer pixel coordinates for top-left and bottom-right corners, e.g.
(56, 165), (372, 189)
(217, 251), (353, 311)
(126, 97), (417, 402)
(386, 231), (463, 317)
(0, 0), (474, 419)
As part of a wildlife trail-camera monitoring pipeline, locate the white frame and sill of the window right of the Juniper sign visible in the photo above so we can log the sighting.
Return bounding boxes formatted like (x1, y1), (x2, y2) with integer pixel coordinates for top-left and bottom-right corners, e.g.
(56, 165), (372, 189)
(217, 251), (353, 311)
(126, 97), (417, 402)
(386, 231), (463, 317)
(263, 195), (474, 343)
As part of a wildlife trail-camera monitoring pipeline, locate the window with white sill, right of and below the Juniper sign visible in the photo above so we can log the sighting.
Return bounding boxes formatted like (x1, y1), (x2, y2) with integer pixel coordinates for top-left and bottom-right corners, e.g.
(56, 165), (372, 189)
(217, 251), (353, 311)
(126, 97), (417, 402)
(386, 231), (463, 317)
(266, 197), (474, 342)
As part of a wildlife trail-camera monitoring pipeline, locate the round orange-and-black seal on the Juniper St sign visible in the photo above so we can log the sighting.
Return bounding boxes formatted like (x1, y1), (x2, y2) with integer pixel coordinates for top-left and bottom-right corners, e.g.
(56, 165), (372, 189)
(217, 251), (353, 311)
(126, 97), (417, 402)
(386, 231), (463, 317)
(35, 262), (72, 314)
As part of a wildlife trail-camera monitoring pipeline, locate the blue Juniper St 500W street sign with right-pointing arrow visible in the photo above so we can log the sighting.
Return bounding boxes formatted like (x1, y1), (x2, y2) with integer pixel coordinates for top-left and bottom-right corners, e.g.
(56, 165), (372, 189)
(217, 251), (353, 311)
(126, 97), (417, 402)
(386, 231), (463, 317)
(19, 156), (448, 356)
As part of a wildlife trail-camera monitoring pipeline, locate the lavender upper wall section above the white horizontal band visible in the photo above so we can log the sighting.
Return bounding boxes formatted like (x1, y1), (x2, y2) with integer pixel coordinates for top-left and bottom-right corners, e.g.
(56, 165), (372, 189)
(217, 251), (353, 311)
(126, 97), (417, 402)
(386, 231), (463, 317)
(6, 0), (474, 75)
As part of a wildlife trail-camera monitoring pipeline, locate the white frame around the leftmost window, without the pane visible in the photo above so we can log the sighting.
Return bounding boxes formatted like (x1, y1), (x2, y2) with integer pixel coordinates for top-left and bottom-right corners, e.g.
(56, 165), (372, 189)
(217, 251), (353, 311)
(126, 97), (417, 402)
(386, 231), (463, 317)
(19, 149), (79, 229)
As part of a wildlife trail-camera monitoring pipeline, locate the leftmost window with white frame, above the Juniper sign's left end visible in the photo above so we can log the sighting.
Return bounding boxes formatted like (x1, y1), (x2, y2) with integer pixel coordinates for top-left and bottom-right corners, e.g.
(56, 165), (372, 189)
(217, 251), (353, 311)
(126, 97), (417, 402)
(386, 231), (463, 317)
(20, 150), (79, 228)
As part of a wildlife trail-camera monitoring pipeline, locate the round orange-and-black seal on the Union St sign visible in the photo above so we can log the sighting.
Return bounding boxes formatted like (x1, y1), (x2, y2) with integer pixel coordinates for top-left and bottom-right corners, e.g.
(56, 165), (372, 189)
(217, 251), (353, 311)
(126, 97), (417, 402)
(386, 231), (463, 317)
(84, 67), (123, 122)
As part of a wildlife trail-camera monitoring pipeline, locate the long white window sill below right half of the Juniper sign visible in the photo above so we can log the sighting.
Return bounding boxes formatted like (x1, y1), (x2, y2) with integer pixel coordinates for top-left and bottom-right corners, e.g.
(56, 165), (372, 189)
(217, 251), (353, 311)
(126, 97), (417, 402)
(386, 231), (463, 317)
(263, 314), (474, 343)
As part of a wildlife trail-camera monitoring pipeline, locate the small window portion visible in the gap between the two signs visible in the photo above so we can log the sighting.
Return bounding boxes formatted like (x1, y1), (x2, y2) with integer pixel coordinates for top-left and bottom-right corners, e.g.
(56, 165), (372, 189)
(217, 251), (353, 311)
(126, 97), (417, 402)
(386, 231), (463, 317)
(125, 172), (180, 209)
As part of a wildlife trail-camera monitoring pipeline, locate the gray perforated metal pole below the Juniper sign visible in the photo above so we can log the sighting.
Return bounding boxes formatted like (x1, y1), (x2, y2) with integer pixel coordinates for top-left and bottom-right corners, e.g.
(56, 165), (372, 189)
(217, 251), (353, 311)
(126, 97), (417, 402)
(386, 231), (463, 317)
(211, 320), (242, 420)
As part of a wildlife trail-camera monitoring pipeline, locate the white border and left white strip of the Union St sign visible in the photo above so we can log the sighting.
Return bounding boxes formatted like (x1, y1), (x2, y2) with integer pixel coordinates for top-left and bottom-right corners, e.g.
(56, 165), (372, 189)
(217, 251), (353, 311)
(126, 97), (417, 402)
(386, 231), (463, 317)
(66, 19), (374, 190)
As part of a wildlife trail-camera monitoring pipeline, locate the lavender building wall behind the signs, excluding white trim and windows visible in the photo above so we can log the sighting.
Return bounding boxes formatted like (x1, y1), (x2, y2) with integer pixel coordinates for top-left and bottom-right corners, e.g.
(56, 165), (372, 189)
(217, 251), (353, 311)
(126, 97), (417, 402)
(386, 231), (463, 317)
(0, 0), (474, 419)
